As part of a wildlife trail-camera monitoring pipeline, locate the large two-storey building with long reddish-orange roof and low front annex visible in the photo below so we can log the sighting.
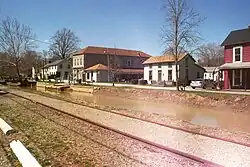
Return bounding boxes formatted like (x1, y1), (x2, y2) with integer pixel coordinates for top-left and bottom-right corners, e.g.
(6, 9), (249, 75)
(73, 46), (150, 82)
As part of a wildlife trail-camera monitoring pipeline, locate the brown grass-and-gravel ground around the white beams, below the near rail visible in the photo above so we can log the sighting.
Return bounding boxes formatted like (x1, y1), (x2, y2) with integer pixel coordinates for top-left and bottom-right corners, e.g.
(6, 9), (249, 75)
(0, 95), (200, 167)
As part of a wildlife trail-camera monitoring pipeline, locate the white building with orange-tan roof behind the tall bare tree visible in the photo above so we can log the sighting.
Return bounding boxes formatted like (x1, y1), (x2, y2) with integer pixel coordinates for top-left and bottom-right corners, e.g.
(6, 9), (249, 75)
(143, 54), (205, 83)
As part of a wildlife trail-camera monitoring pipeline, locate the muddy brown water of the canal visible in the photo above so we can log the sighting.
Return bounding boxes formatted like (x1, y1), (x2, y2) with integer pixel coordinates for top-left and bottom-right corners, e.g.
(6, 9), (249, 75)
(32, 87), (250, 133)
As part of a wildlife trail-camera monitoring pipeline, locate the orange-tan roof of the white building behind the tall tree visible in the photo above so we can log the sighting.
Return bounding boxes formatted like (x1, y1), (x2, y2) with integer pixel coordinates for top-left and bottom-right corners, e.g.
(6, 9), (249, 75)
(142, 54), (189, 64)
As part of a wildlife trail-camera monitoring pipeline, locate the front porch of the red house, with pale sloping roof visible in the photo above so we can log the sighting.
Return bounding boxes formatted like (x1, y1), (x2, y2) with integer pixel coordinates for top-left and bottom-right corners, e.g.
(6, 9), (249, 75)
(220, 62), (250, 90)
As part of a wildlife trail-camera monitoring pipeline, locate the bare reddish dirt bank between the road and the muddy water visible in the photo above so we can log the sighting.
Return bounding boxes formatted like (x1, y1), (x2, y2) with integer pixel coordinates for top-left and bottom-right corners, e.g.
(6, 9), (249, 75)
(94, 87), (250, 112)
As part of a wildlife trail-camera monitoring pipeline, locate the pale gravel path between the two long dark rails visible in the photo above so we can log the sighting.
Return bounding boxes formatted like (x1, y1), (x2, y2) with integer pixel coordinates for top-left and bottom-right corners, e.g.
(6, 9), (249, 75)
(10, 90), (250, 167)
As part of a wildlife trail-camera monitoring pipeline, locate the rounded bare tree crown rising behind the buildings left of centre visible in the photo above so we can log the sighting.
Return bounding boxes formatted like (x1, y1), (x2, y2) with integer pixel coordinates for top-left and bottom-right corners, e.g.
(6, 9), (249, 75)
(49, 28), (80, 59)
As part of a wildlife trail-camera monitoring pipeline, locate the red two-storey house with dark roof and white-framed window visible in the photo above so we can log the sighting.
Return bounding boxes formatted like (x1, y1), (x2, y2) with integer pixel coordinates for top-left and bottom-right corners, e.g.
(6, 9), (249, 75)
(220, 26), (250, 89)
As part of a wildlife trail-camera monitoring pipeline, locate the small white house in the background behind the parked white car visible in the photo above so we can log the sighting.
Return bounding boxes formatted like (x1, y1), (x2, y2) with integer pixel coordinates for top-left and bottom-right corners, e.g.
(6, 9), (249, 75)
(203, 67), (224, 81)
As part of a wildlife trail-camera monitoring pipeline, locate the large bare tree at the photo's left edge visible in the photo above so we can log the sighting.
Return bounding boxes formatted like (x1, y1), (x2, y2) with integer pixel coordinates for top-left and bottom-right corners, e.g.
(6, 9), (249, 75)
(0, 17), (36, 80)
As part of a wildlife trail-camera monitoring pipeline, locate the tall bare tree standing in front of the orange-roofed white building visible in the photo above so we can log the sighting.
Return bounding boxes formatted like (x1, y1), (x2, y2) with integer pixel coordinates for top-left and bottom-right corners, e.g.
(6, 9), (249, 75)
(161, 0), (204, 90)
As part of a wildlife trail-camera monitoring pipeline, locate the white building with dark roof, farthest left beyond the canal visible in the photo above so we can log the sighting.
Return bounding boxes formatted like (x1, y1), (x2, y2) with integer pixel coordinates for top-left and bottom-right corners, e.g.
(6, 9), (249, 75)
(41, 58), (72, 83)
